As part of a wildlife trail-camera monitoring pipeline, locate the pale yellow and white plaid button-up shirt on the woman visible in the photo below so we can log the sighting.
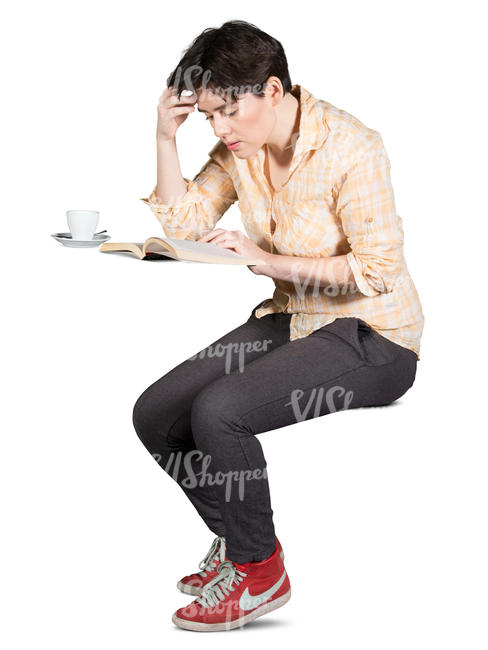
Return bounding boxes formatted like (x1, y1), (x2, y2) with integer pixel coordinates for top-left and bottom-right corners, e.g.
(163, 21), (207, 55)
(141, 84), (424, 359)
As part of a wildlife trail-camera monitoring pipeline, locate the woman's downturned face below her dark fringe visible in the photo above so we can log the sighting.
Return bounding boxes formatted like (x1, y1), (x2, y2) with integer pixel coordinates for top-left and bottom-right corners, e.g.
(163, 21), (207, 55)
(197, 89), (276, 158)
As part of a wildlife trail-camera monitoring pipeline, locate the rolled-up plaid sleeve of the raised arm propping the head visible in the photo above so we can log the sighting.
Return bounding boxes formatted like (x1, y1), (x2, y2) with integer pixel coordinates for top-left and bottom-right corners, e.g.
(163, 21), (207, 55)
(141, 145), (238, 240)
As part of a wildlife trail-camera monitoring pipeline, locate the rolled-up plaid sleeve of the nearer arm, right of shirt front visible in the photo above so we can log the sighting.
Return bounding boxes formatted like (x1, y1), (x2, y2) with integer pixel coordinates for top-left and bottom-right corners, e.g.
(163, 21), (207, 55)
(336, 138), (404, 296)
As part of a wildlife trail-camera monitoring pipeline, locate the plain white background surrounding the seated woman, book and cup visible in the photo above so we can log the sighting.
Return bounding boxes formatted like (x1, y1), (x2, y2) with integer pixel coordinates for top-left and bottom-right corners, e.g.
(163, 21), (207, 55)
(0, 0), (488, 650)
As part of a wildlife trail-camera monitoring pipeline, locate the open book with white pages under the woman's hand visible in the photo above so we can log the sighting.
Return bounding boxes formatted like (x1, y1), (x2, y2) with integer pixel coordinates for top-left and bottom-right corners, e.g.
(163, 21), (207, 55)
(99, 237), (266, 266)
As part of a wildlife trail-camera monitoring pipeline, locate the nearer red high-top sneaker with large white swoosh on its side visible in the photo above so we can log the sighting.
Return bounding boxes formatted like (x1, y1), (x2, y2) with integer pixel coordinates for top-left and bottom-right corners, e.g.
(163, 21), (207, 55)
(173, 545), (291, 632)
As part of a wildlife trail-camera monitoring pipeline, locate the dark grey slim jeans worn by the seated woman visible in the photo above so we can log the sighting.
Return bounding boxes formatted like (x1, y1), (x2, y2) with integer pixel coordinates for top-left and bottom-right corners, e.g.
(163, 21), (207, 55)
(133, 301), (417, 563)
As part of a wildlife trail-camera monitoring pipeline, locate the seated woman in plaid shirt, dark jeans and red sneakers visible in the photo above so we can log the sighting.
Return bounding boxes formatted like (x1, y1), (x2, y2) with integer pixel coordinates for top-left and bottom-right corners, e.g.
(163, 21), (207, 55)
(134, 21), (424, 630)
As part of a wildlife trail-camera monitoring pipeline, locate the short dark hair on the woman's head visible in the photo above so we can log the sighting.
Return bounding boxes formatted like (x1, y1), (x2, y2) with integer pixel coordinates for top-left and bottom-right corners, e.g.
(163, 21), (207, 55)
(166, 20), (292, 100)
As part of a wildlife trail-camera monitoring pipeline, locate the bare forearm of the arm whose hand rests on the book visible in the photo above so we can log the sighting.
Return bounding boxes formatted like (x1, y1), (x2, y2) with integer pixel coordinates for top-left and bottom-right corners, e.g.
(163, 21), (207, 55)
(262, 253), (356, 288)
